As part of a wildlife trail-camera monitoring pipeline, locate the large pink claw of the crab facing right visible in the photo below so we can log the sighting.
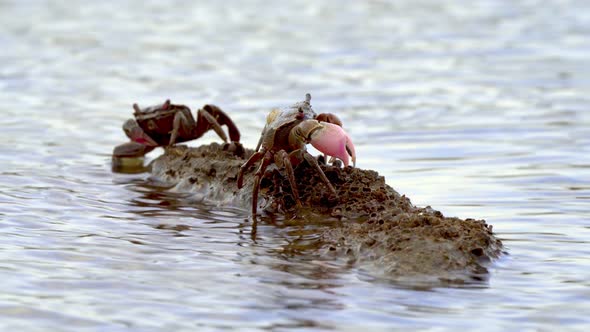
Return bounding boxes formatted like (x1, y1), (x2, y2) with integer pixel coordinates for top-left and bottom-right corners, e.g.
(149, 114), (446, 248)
(311, 122), (356, 166)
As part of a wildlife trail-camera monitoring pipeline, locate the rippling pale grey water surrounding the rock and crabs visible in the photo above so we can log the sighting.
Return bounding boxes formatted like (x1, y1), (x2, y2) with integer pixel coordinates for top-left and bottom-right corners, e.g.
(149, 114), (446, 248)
(0, 0), (590, 331)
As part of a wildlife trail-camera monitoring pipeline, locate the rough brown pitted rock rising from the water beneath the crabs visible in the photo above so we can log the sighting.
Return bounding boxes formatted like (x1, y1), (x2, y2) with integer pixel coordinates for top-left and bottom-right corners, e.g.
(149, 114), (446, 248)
(151, 143), (502, 283)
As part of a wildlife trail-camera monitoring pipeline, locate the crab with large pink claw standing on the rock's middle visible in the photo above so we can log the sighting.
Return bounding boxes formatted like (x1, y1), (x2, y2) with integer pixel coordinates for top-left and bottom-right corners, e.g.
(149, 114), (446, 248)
(237, 93), (356, 216)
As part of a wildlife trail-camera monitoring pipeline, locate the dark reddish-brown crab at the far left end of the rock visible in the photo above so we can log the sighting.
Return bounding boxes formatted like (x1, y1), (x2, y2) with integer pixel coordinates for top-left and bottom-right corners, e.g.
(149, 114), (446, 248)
(113, 99), (240, 158)
